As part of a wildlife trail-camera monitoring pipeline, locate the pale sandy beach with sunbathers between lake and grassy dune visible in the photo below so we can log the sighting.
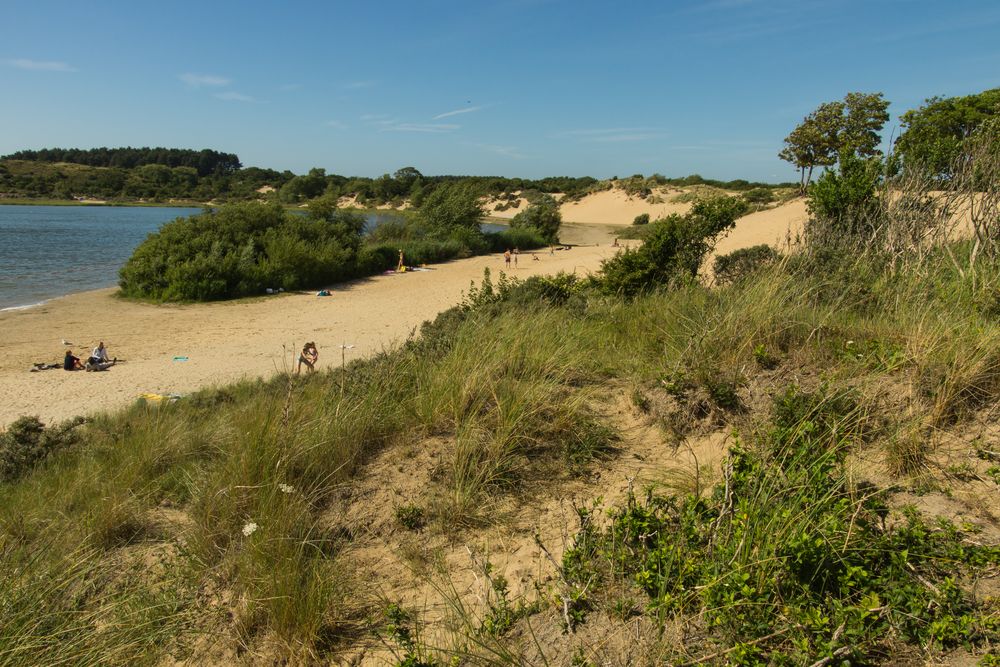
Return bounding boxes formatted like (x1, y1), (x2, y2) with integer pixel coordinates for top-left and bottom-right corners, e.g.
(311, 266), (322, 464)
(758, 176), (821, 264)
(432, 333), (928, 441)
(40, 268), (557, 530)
(0, 202), (804, 427)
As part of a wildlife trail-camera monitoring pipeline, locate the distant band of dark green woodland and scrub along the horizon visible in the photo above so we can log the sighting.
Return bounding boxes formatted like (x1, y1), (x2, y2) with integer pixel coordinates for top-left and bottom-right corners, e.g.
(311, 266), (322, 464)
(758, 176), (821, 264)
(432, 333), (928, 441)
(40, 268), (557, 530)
(0, 147), (789, 207)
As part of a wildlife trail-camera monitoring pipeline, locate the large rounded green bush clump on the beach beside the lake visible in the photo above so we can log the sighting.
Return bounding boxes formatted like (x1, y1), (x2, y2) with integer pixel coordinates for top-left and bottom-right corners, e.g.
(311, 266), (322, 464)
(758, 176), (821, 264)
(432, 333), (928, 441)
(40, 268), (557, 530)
(119, 188), (558, 301)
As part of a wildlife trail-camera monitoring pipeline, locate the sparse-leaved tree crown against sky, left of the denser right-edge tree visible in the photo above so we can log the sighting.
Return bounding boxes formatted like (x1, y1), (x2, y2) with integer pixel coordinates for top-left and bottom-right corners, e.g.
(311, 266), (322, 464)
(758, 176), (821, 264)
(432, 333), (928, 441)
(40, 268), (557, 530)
(778, 93), (889, 192)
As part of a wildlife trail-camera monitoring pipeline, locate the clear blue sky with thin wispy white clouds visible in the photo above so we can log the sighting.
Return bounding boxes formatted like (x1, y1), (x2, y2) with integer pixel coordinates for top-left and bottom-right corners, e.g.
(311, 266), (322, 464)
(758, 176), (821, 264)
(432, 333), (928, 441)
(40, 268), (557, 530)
(0, 0), (1000, 181)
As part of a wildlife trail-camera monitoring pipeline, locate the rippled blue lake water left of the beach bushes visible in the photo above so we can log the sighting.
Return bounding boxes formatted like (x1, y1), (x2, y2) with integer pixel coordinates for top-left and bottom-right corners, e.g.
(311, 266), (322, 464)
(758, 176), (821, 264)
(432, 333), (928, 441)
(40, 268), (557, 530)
(0, 206), (503, 310)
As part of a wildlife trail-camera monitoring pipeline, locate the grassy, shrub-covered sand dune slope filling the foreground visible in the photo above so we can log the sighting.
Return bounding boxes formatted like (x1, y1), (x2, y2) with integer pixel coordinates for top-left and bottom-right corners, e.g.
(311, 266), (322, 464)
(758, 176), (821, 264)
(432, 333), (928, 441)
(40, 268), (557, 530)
(0, 87), (1000, 667)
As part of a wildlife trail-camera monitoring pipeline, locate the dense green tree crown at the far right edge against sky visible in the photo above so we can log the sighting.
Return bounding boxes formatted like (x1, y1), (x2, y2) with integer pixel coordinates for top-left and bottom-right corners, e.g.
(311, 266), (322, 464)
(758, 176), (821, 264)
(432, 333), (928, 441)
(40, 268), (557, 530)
(895, 88), (1000, 178)
